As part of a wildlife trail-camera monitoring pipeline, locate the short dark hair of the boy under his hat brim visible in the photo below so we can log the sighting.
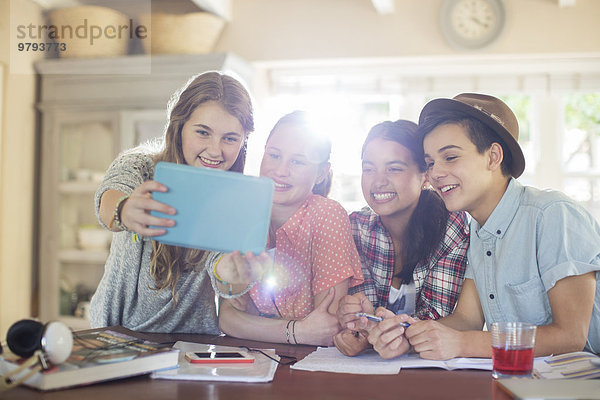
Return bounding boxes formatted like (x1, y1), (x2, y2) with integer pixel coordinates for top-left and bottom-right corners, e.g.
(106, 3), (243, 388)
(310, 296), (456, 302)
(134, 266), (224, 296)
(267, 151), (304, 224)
(419, 111), (513, 177)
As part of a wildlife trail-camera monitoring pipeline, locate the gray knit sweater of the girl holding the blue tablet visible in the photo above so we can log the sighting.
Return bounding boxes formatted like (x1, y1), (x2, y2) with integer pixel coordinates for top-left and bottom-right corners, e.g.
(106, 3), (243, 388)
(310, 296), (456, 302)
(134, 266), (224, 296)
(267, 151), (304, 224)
(90, 153), (220, 334)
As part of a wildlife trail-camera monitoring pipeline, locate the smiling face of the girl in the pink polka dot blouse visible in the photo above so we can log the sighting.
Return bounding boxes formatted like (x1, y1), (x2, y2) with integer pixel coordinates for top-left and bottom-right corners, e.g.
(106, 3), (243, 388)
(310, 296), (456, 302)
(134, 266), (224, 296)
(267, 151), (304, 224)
(260, 123), (329, 212)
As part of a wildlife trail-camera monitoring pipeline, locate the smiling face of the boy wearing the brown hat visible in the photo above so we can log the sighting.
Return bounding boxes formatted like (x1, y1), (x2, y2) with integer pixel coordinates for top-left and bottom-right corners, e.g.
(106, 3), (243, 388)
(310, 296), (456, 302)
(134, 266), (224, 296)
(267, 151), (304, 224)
(423, 124), (508, 225)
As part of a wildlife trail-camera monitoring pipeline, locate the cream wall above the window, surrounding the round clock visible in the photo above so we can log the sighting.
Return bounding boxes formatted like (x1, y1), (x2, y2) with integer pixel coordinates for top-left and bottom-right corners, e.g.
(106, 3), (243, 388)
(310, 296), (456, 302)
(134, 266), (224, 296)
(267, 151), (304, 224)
(216, 0), (600, 61)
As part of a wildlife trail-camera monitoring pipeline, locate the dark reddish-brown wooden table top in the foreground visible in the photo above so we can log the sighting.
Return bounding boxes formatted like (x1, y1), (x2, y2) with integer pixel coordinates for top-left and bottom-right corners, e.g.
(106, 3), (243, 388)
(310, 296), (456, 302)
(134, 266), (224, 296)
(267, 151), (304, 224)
(0, 327), (510, 400)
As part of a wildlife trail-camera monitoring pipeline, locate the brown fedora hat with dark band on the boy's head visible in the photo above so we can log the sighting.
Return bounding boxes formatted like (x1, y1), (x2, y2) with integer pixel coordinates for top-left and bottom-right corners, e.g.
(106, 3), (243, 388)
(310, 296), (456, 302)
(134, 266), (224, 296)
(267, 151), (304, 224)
(419, 93), (525, 178)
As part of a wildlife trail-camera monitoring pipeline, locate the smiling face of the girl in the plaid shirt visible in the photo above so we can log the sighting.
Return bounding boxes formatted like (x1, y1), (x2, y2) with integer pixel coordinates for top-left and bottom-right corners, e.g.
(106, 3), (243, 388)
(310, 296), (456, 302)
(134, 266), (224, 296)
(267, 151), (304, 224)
(361, 138), (425, 217)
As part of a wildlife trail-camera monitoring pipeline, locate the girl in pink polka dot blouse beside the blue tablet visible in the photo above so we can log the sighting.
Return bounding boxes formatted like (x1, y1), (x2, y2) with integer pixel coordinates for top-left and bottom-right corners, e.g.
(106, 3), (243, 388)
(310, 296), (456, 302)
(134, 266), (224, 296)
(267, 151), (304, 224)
(213, 111), (363, 346)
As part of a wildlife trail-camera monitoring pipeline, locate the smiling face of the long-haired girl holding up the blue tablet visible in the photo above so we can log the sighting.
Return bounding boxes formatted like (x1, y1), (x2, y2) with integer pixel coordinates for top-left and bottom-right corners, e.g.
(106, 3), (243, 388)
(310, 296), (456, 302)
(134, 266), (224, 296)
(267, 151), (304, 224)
(181, 101), (245, 170)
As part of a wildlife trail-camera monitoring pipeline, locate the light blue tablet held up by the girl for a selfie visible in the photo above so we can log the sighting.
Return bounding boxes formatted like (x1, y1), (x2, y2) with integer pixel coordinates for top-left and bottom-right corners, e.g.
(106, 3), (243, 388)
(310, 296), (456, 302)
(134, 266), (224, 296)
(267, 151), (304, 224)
(151, 162), (273, 254)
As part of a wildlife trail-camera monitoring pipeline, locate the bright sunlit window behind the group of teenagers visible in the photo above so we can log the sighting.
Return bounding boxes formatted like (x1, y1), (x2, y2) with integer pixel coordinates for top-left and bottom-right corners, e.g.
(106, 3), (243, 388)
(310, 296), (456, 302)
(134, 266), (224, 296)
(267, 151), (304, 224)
(255, 55), (600, 220)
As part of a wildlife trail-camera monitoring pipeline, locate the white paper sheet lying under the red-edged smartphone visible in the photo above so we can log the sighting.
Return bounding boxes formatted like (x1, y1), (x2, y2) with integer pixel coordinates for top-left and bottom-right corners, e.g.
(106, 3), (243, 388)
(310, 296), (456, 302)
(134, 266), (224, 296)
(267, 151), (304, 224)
(150, 341), (279, 382)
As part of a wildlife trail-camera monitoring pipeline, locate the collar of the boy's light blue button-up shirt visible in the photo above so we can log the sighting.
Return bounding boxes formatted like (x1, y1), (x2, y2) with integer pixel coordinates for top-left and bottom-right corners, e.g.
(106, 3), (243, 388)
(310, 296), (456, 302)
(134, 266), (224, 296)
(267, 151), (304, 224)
(471, 178), (525, 239)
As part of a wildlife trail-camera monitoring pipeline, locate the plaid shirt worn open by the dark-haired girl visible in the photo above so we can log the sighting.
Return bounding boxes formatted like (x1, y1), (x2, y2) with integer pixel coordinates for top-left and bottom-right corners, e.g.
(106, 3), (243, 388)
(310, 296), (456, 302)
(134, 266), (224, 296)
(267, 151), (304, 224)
(349, 207), (469, 319)
